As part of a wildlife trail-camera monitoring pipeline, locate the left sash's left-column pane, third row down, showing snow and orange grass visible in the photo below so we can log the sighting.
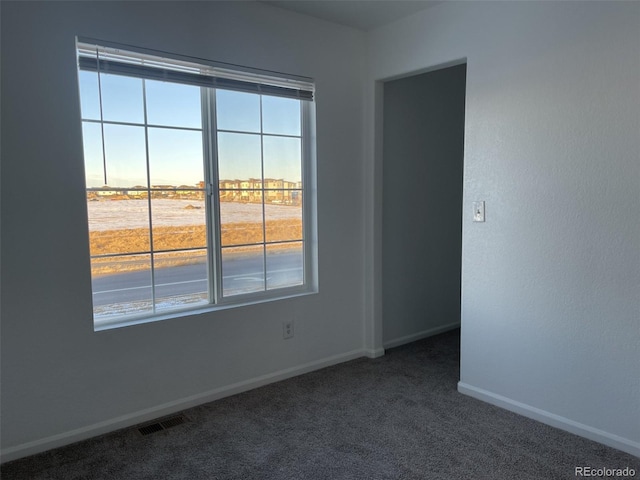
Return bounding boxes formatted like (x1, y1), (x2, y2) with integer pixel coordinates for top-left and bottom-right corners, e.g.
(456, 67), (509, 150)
(87, 196), (150, 255)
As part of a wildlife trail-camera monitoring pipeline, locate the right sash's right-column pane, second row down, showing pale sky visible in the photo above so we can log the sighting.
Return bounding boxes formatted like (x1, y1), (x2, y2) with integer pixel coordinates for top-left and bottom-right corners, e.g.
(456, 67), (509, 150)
(263, 136), (302, 185)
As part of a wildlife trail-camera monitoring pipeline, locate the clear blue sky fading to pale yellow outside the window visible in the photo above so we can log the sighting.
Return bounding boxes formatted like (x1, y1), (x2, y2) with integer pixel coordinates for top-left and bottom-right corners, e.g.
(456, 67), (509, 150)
(79, 71), (301, 187)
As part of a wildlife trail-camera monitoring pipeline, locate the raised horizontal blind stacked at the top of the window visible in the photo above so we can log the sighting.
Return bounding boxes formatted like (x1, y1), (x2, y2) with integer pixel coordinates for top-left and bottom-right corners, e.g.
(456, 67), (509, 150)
(78, 43), (314, 100)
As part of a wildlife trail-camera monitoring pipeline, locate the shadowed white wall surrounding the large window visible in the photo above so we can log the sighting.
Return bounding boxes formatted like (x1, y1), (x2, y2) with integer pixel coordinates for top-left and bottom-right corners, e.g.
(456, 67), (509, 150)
(1, 2), (366, 460)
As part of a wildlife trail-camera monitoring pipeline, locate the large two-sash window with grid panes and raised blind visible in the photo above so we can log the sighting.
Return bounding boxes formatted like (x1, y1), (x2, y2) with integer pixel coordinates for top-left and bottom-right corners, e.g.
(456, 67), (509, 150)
(78, 41), (317, 328)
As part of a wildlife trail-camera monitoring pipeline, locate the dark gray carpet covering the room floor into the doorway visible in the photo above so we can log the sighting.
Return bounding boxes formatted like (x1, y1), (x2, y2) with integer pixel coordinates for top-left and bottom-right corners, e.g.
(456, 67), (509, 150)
(0, 330), (640, 480)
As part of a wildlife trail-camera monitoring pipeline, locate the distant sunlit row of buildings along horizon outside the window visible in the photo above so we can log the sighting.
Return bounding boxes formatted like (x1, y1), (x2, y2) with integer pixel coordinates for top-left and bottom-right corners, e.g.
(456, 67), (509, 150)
(87, 178), (302, 205)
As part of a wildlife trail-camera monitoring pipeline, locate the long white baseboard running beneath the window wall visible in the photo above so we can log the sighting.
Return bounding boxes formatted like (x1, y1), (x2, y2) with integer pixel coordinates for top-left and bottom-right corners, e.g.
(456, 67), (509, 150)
(0, 350), (369, 463)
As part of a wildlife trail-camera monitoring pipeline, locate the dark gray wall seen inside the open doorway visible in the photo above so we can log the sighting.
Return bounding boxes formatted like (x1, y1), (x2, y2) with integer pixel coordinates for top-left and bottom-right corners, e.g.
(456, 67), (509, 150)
(382, 65), (466, 348)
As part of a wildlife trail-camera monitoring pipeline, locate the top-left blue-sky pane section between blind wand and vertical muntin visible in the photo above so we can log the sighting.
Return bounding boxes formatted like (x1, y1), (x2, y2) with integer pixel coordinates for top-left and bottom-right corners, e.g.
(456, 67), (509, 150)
(100, 73), (144, 123)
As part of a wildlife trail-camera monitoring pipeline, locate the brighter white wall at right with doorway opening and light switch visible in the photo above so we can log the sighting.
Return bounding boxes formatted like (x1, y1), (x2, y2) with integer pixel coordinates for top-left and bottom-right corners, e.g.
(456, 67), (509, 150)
(366, 2), (640, 455)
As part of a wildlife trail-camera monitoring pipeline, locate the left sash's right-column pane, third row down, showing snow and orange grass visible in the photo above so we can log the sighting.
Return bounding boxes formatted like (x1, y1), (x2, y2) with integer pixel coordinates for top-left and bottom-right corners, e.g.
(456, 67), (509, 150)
(151, 199), (207, 252)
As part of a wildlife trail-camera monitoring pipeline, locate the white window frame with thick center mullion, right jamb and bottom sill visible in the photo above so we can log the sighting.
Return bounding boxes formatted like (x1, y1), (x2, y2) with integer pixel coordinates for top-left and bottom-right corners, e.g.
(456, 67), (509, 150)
(76, 38), (318, 331)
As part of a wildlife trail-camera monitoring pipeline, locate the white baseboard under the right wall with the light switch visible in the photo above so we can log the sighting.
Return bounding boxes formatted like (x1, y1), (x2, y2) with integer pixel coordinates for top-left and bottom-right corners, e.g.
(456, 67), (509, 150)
(458, 382), (640, 457)
